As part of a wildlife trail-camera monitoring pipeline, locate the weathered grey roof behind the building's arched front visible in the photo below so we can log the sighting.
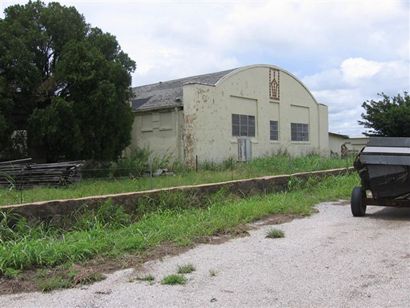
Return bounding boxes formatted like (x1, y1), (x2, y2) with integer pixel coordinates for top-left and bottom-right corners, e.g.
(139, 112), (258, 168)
(131, 69), (235, 112)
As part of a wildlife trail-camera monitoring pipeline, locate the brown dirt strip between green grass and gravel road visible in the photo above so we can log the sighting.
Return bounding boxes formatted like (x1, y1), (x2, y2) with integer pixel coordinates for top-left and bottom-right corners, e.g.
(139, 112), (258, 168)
(0, 214), (303, 295)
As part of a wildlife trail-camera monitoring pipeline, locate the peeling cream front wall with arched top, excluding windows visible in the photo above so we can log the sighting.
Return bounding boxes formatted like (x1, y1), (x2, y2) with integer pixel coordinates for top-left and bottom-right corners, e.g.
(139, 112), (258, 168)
(183, 65), (329, 164)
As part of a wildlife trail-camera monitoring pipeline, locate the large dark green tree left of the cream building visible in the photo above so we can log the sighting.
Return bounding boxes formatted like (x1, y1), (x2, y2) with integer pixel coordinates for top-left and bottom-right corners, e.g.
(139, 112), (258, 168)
(0, 1), (135, 161)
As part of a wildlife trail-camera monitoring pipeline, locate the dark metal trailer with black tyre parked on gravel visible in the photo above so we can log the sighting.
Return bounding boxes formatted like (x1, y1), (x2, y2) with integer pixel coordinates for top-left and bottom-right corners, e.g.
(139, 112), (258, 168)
(350, 137), (410, 217)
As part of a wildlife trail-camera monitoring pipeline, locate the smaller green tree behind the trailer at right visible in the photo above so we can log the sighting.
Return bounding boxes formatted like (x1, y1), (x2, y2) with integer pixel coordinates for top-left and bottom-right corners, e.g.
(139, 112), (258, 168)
(359, 92), (410, 137)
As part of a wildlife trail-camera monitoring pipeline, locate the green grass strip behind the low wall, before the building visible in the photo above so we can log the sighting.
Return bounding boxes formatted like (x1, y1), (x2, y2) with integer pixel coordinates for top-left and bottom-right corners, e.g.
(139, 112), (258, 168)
(0, 155), (352, 206)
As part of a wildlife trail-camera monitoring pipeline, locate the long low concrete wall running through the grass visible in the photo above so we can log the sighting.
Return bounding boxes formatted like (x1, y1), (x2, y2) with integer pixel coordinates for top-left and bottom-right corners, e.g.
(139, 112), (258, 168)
(0, 168), (354, 220)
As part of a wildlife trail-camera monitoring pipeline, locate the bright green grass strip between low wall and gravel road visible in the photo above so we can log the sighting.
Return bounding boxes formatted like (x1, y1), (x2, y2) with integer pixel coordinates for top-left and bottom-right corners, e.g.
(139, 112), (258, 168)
(0, 174), (359, 275)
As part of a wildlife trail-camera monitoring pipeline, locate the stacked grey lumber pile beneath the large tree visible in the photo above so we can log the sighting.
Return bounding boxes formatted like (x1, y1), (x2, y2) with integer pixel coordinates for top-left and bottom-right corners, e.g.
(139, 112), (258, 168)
(0, 158), (82, 189)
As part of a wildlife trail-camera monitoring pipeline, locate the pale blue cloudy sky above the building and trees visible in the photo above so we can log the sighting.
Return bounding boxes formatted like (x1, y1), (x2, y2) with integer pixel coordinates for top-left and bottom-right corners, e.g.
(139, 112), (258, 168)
(0, 0), (410, 136)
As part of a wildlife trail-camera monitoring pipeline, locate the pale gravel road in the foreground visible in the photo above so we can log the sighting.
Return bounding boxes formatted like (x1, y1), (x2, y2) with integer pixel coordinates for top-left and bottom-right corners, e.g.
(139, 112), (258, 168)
(0, 203), (410, 307)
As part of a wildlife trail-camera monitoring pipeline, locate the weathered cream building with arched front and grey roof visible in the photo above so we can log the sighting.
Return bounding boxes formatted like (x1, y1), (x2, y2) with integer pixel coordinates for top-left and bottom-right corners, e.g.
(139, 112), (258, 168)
(132, 65), (329, 164)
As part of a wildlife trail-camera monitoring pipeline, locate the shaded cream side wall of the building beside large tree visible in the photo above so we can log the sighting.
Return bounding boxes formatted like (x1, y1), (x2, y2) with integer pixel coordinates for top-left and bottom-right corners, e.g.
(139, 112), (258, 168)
(130, 108), (183, 160)
